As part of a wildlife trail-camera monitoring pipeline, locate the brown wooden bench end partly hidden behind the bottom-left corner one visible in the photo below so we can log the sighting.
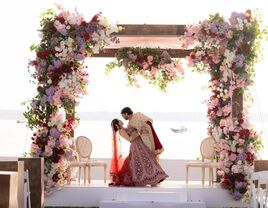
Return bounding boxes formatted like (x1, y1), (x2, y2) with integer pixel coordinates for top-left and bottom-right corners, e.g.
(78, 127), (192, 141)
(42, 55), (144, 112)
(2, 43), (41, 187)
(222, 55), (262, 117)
(0, 161), (24, 208)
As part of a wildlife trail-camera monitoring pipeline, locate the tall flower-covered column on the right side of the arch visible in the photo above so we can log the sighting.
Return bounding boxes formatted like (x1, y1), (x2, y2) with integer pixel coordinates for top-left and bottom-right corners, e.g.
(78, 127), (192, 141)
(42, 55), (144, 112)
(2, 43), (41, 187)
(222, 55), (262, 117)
(182, 10), (266, 200)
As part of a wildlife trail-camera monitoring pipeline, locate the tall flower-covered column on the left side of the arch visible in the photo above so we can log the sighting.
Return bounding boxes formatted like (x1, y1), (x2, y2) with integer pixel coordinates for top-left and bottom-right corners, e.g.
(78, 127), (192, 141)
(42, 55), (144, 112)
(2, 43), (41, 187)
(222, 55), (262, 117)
(24, 7), (118, 194)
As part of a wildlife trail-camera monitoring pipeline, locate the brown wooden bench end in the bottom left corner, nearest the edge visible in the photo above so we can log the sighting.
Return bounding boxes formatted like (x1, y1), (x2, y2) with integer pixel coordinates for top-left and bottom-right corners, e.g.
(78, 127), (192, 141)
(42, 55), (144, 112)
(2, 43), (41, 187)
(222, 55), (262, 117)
(0, 171), (18, 208)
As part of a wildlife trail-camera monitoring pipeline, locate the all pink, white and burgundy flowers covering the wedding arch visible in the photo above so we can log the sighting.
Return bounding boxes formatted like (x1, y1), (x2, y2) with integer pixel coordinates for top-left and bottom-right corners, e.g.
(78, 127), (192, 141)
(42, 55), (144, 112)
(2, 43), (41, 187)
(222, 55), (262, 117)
(24, 5), (265, 200)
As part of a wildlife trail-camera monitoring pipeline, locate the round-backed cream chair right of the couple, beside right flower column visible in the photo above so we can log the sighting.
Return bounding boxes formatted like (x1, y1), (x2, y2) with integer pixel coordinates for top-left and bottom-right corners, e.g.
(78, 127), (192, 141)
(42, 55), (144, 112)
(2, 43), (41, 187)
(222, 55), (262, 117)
(185, 137), (218, 185)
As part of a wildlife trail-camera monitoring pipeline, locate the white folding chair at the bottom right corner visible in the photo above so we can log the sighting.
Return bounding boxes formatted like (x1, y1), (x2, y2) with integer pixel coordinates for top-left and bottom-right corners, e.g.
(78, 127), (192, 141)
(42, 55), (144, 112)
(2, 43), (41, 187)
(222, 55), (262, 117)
(249, 171), (268, 208)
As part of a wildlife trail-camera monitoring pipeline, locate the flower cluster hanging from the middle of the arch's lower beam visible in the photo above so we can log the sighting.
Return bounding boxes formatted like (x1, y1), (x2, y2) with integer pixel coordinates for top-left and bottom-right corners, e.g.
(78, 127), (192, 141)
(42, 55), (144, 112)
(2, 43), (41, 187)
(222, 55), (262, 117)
(106, 47), (184, 91)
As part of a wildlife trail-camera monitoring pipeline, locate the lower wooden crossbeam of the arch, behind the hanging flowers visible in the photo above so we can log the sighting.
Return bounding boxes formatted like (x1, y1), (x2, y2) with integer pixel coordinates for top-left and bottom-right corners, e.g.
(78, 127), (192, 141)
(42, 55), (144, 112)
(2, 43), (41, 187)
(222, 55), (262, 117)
(92, 49), (192, 58)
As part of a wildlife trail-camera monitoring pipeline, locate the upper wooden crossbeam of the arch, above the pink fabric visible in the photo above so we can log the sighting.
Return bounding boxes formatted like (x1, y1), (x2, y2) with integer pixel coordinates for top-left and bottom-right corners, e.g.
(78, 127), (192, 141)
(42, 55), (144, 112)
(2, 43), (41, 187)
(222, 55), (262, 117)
(115, 24), (185, 36)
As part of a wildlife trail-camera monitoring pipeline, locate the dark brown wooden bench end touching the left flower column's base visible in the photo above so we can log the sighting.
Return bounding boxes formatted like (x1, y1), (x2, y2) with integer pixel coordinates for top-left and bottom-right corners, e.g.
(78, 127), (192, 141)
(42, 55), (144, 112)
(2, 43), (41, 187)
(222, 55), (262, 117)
(19, 157), (44, 208)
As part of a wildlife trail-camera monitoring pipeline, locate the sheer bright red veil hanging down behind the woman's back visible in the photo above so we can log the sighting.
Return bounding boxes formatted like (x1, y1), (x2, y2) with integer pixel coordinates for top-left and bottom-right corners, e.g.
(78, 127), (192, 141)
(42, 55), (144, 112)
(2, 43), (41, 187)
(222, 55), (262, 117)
(110, 131), (124, 185)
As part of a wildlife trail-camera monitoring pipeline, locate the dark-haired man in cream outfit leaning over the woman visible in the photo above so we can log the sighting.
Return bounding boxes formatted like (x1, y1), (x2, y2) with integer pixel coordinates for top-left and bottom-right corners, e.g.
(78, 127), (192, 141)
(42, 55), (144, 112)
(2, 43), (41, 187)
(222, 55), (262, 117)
(121, 107), (164, 156)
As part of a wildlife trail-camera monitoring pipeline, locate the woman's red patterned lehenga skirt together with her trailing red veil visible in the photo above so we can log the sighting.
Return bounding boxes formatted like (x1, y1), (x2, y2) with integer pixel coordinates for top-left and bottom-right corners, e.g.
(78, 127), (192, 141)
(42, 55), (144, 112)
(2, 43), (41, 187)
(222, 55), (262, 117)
(110, 129), (168, 186)
